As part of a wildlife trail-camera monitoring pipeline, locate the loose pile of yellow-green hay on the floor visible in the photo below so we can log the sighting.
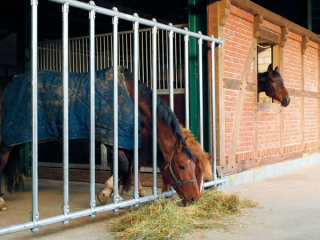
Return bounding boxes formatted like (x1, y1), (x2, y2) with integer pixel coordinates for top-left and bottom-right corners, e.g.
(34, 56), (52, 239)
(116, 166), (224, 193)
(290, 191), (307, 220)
(109, 189), (258, 239)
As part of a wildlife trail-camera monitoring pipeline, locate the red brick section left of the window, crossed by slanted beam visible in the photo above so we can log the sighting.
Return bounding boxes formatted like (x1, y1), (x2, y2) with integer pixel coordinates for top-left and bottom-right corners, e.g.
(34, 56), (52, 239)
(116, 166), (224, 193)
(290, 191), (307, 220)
(224, 6), (254, 161)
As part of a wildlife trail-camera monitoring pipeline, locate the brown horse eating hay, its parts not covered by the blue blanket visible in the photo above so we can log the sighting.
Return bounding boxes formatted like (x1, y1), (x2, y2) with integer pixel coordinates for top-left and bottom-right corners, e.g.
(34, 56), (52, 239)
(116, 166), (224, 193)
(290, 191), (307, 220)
(0, 67), (200, 210)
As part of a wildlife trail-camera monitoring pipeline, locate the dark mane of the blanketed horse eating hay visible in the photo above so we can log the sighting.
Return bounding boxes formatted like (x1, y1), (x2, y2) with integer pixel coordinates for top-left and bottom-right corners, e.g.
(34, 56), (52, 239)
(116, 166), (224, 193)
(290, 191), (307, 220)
(121, 68), (194, 161)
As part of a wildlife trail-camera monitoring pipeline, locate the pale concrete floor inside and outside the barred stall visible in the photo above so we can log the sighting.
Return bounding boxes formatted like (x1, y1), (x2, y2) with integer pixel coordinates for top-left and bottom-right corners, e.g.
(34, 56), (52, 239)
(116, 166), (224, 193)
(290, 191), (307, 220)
(0, 164), (320, 240)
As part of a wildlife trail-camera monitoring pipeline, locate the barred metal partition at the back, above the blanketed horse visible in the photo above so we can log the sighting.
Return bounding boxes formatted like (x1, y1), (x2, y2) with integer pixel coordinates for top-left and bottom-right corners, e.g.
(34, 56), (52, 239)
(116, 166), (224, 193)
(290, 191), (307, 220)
(38, 24), (187, 94)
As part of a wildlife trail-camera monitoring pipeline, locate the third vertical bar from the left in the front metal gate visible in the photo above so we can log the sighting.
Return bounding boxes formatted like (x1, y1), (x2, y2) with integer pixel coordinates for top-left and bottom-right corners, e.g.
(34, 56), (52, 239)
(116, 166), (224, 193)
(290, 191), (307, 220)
(89, 1), (96, 215)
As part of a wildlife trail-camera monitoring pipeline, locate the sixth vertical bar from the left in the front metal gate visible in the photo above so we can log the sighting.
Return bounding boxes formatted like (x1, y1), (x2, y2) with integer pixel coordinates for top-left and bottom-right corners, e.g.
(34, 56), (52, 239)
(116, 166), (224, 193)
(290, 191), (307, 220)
(152, 19), (158, 195)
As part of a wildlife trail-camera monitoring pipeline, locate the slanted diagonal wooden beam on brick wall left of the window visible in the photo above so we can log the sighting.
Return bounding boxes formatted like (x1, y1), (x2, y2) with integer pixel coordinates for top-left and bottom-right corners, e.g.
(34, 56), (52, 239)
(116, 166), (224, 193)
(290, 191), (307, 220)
(228, 40), (257, 162)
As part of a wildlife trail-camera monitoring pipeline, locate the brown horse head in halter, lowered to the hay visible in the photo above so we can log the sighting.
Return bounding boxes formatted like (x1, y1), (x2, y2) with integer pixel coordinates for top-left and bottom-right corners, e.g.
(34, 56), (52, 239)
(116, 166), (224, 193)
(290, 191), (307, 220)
(161, 140), (200, 206)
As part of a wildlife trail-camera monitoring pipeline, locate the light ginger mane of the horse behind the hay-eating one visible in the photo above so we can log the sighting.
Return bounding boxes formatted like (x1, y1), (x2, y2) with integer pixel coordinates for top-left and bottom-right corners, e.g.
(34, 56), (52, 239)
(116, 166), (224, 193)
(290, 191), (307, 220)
(180, 125), (212, 179)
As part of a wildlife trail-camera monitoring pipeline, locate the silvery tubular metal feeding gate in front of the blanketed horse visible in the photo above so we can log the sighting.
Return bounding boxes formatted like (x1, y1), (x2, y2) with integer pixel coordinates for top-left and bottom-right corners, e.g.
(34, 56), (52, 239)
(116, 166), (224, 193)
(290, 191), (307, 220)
(0, 0), (224, 235)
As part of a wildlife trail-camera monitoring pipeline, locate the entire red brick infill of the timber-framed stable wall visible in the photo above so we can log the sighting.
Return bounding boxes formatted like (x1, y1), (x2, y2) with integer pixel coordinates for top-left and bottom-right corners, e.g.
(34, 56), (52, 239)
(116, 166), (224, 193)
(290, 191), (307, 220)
(223, 3), (320, 172)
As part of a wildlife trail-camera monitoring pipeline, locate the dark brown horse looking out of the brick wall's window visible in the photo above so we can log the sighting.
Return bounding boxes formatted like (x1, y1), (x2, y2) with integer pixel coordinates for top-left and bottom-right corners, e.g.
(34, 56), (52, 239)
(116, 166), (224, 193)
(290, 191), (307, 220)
(258, 64), (290, 107)
